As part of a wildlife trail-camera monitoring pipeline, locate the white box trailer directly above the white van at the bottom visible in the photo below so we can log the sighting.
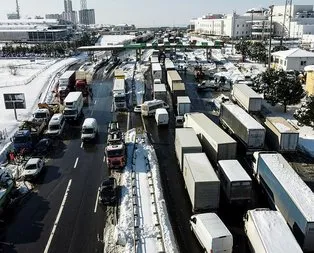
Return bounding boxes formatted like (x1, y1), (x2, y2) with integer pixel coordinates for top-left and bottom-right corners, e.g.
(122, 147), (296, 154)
(183, 153), (220, 212)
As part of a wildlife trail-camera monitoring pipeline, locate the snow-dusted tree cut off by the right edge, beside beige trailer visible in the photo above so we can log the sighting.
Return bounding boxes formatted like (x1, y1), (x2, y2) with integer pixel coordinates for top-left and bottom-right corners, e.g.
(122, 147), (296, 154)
(294, 96), (314, 127)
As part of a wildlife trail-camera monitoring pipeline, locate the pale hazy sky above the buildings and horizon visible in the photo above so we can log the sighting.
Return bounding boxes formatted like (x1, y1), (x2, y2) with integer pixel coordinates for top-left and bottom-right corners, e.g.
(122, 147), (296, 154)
(0, 0), (314, 27)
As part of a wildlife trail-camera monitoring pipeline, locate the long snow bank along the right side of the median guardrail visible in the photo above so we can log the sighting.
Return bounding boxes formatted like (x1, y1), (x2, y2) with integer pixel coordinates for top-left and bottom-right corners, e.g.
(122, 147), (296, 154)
(143, 141), (179, 253)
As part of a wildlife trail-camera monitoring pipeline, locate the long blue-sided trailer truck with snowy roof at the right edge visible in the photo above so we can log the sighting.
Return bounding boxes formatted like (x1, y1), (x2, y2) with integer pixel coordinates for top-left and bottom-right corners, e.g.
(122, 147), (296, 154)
(253, 152), (314, 252)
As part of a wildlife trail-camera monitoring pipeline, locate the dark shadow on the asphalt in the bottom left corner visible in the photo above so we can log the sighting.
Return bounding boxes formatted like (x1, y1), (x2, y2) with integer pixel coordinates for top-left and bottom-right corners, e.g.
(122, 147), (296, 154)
(0, 192), (50, 253)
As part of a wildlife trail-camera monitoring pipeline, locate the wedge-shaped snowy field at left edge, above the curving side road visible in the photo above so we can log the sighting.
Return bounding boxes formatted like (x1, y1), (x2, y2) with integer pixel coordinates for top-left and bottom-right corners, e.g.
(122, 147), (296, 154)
(0, 59), (56, 87)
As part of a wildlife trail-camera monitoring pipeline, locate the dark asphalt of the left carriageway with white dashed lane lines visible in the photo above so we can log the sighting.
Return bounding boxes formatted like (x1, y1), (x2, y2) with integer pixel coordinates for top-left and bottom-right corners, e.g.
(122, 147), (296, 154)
(0, 65), (112, 253)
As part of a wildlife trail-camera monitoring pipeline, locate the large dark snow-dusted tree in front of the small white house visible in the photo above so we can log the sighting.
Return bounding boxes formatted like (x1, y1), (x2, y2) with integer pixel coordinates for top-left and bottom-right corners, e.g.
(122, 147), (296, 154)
(253, 69), (305, 112)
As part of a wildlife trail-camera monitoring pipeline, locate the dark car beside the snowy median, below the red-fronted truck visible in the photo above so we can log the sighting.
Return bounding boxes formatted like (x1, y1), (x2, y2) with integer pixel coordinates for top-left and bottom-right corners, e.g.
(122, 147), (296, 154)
(99, 177), (117, 205)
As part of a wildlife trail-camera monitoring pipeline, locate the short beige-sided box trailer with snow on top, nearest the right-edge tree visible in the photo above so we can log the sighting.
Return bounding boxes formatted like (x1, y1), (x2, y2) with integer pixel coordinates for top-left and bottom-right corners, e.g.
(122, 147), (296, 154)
(265, 117), (299, 152)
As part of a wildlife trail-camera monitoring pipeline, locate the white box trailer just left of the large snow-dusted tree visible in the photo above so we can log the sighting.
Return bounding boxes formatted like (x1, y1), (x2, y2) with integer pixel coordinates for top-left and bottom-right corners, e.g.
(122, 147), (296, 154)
(231, 83), (263, 112)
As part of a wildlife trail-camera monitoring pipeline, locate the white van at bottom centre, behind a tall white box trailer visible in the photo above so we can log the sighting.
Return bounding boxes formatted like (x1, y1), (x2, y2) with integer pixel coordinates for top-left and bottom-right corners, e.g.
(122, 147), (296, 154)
(190, 213), (233, 253)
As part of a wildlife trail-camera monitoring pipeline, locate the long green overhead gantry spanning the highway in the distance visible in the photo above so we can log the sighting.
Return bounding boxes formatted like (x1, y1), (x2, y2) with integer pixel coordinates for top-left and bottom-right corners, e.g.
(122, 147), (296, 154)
(78, 40), (223, 59)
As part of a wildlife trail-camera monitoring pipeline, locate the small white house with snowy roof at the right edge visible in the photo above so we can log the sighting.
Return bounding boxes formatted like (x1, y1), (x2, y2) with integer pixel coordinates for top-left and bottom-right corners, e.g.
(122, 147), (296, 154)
(272, 48), (314, 71)
